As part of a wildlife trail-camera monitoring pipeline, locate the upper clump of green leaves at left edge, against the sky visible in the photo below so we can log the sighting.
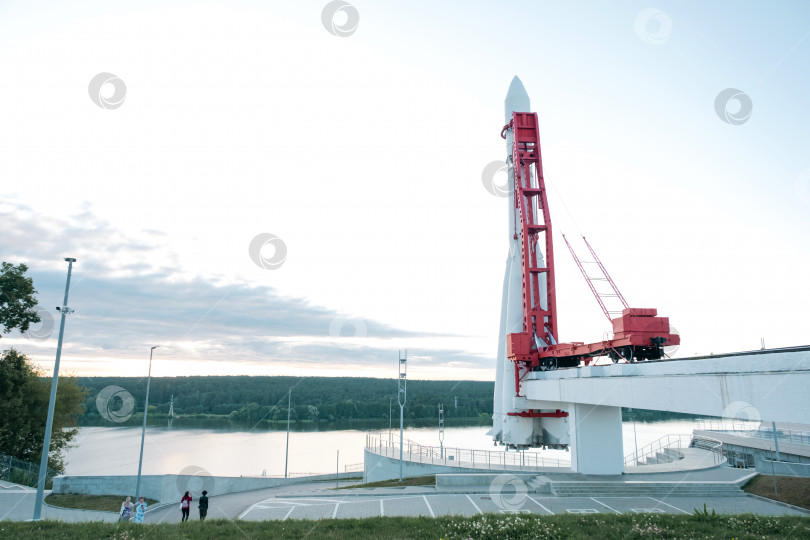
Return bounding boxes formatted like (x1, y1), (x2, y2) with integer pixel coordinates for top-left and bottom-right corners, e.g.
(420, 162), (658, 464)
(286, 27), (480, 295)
(0, 262), (40, 334)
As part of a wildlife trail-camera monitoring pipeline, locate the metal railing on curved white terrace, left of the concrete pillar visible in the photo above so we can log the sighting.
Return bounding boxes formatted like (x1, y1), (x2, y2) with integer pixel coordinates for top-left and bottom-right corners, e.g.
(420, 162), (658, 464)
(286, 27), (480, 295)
(366, 433), (571, 471)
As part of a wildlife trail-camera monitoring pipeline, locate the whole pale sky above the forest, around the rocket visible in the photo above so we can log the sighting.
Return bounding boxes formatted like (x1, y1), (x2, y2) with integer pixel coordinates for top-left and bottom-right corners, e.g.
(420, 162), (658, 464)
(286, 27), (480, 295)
(0, 0), (810, 380)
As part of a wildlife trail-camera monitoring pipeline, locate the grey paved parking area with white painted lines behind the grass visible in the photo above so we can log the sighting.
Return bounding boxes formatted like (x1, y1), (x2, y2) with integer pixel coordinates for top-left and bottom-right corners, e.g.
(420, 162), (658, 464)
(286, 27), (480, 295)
(0, 476), (810, 523)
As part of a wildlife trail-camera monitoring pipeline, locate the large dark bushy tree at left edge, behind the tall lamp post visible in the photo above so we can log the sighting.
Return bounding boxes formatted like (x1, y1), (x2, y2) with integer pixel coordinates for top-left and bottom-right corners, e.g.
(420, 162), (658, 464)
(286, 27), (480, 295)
(0, 349), (87, 471)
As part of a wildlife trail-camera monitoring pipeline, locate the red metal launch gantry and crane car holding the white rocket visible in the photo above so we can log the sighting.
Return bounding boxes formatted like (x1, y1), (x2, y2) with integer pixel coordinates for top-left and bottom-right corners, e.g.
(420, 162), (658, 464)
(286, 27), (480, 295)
(501, 112), (680, 396)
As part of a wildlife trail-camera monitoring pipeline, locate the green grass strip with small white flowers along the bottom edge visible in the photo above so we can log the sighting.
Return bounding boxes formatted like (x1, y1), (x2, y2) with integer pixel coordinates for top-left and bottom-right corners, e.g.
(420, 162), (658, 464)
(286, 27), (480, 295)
(0, 514), (810, 540)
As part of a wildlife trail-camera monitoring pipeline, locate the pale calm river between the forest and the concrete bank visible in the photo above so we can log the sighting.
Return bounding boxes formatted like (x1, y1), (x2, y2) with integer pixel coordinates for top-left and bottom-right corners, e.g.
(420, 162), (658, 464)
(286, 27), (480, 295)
(65, 420), (695, 476)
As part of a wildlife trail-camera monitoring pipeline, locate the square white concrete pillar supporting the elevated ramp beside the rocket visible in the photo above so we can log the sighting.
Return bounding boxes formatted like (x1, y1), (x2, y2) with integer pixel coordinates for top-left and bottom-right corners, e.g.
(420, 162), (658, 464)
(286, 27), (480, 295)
(569, 403), (624, 474)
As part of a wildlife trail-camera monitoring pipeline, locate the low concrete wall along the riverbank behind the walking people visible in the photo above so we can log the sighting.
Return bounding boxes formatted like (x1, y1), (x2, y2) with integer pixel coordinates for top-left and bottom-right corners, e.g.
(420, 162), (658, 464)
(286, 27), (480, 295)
(53, 472), (360, 503)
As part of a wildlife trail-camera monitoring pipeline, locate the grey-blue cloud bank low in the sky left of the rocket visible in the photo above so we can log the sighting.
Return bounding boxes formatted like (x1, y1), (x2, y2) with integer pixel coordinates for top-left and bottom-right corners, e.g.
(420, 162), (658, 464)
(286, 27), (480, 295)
(0, 202), (490, 378)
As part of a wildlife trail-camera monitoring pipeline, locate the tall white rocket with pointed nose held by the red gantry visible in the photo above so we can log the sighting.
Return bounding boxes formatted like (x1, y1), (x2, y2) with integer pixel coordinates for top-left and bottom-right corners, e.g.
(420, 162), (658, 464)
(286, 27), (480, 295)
(488, 76), (568, 448)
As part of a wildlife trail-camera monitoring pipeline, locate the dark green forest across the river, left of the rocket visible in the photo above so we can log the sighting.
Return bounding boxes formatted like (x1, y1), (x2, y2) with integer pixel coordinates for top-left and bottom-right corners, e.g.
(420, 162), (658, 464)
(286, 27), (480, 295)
(77, 376), (494, 425)
